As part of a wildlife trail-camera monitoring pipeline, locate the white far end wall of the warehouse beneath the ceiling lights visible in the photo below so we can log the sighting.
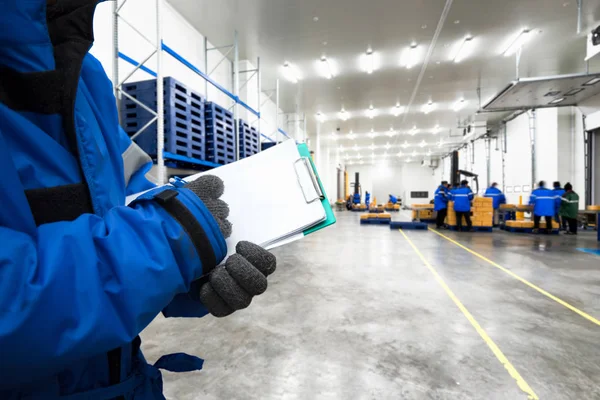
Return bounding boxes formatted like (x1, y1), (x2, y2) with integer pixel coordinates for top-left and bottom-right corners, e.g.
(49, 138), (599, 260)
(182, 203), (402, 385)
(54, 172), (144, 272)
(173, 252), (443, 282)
(348, 163), (439, 204)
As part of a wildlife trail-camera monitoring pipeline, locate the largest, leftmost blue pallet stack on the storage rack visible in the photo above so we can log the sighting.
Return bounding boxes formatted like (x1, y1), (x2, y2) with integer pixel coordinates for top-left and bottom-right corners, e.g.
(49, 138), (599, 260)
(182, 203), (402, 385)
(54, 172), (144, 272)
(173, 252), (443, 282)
(121, 77), (206, 160)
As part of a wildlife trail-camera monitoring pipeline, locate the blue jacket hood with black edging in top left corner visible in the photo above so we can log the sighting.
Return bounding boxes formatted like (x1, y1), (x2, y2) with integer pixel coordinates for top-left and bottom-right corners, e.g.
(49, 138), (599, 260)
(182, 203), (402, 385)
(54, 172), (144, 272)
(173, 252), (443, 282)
(0, 0), (104, 72)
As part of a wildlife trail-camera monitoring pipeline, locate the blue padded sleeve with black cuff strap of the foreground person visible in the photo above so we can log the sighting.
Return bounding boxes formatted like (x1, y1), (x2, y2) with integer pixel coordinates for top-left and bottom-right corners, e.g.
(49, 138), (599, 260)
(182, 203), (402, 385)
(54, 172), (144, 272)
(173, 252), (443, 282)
(0, 188), (227, 385)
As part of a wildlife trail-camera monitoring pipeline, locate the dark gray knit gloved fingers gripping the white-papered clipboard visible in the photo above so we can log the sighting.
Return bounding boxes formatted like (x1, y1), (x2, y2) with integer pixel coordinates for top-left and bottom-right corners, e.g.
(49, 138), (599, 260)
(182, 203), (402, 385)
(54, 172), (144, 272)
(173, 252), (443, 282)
(186, 175), (277, 317)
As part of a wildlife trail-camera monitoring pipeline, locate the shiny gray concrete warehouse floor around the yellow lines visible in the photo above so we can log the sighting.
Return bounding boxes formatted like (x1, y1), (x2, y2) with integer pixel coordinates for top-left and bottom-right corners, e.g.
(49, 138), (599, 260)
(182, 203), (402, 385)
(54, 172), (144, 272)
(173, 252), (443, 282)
(142, 212), (600, 400)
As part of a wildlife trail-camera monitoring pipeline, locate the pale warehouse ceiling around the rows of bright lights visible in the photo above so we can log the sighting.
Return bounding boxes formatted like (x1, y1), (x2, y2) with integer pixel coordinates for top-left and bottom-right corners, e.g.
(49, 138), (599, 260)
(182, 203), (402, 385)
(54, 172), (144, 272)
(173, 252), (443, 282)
(169, 0), (600, 161)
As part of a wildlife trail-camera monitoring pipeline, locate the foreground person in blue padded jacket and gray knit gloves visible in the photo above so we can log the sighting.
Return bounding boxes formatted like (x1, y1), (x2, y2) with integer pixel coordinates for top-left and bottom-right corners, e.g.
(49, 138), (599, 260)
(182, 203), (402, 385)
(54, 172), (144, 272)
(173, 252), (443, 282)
(0, 0), (276, 400)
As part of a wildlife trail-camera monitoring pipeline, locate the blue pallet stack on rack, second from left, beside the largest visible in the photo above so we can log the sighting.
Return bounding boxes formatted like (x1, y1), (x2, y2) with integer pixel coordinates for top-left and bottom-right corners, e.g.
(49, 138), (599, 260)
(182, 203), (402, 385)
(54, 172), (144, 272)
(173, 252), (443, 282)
(204, 102), (235, 165)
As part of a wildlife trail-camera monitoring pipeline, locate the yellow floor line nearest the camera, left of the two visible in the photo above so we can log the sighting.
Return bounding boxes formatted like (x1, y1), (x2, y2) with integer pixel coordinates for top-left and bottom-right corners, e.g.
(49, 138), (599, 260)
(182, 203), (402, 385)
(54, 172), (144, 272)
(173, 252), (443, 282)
(400, 229), (539, 400)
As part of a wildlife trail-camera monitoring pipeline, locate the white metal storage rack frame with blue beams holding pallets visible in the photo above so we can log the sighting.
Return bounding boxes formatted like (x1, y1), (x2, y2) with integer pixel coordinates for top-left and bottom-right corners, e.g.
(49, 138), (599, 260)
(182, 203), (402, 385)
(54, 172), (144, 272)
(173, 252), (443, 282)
(112, 0), (289, 184)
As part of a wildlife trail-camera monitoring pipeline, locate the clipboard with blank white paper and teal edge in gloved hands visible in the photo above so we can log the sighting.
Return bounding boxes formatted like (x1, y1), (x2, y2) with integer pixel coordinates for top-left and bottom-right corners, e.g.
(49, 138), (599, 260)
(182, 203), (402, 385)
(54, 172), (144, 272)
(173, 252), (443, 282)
(127, 141), (336, 252)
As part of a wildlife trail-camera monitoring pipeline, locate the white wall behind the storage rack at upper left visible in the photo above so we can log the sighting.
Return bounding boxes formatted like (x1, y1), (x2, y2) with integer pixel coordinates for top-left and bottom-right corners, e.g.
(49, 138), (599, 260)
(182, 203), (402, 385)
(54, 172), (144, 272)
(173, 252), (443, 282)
(90, 0), (281, 140)
